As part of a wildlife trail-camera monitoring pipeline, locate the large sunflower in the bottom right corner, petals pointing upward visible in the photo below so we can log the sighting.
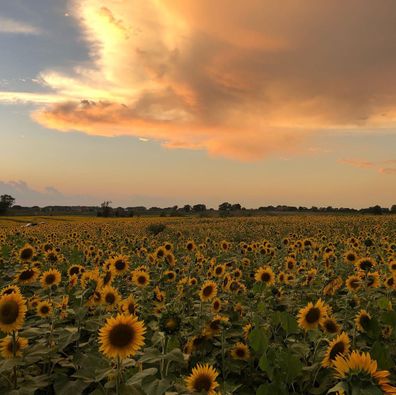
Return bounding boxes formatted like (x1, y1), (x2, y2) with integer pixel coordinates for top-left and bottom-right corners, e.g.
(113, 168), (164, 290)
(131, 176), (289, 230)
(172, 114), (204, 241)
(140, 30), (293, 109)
(333, 351), (396, 394)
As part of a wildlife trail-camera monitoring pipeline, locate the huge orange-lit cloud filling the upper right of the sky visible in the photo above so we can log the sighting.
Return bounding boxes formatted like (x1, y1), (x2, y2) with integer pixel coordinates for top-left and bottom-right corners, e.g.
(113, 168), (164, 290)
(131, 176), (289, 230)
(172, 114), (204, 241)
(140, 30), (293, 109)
(2, 0), (396, 160)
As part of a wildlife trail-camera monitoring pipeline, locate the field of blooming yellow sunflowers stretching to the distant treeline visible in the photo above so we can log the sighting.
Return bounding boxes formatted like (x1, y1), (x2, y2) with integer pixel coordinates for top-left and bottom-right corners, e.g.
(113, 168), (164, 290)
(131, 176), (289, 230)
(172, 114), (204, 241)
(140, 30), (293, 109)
(0, 215), (396, 395)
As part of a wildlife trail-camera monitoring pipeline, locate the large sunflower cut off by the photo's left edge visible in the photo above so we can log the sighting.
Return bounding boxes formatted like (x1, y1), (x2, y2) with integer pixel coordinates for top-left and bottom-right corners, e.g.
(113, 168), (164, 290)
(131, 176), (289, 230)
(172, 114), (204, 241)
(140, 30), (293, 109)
(0, 293), (27, 333)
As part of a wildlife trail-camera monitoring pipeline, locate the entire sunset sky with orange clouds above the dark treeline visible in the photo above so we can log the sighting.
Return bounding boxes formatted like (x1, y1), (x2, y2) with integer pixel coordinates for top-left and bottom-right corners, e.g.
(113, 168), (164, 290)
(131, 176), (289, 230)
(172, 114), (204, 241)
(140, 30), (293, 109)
(0, 0), (396, 208)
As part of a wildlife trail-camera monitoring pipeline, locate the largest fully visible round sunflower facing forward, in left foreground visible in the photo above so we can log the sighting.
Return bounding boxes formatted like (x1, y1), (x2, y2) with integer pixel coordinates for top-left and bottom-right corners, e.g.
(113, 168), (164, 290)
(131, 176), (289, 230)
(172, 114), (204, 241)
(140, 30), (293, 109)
(99, 314), (146, 358)
